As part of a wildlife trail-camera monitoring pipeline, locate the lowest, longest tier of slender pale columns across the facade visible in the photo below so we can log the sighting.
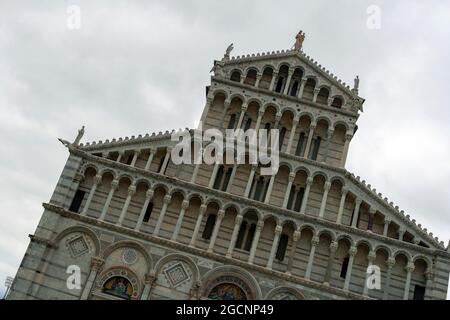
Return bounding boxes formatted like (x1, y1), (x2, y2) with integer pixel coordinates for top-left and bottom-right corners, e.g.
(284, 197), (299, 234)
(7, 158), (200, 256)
(76, 176), (431, 299)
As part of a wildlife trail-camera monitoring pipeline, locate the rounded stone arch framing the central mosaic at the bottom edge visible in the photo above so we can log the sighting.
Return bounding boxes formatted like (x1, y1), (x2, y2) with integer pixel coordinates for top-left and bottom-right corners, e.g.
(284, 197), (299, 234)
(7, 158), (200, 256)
(201, 265), (262, 300)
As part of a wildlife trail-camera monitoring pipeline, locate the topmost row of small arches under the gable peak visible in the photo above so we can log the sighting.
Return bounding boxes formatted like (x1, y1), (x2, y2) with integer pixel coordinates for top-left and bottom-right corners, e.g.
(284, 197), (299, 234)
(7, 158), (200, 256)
(230, 64), (345, 109)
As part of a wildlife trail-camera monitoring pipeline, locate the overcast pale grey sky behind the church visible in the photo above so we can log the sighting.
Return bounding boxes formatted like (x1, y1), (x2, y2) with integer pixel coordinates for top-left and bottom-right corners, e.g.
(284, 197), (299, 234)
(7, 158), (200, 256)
(0, 0), (450, 294)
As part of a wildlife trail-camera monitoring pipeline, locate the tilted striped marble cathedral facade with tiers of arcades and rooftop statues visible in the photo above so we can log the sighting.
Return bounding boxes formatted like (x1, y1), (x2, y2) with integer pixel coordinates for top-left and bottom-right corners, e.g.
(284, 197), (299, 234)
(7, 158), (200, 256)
(7, 35), (450, 300)
